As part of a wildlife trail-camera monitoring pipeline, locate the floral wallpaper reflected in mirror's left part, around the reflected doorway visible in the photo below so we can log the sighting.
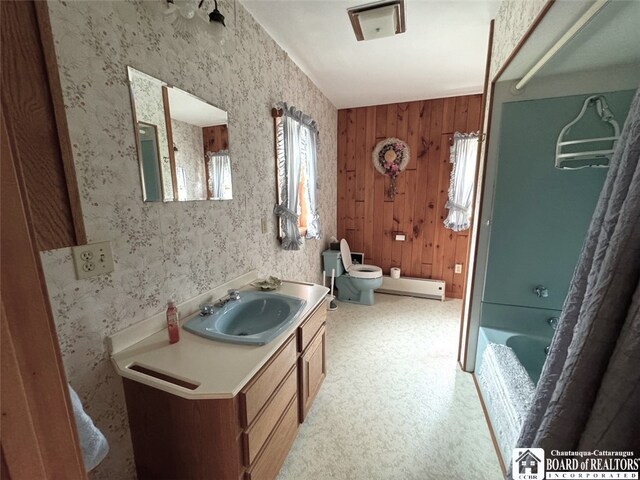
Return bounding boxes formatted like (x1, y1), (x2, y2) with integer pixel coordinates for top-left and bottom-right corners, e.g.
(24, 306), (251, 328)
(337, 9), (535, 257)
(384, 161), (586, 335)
(129, 69), (173, 200)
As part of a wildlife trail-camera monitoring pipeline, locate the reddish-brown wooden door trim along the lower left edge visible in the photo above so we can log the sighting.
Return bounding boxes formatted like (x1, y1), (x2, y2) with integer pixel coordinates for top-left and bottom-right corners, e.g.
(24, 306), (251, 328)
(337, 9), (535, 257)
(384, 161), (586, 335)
(0, 111), (87, 479)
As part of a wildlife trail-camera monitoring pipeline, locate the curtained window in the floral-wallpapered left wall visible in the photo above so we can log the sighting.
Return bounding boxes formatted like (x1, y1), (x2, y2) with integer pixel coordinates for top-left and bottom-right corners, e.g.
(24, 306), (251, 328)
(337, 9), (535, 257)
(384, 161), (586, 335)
(274, 103), (320, 250)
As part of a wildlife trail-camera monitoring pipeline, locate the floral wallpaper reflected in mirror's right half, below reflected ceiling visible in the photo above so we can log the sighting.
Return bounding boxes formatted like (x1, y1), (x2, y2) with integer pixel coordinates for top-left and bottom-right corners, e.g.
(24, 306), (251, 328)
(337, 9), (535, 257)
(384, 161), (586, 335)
(171, 118), (207, 200)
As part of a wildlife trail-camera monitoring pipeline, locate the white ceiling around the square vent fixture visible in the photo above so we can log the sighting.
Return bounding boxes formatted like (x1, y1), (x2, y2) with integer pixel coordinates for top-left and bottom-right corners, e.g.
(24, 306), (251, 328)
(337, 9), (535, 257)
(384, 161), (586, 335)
(241, 0), (501, 108)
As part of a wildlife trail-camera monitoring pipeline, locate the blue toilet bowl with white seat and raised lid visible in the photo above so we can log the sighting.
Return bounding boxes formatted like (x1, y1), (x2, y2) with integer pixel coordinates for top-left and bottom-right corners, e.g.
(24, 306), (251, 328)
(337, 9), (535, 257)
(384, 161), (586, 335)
(336, 238), (382, 305)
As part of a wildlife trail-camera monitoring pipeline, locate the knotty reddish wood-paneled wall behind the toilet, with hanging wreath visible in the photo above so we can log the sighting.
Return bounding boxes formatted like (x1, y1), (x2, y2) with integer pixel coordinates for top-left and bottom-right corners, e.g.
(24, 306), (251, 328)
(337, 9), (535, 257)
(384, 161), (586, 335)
(338, 95), (482, 298)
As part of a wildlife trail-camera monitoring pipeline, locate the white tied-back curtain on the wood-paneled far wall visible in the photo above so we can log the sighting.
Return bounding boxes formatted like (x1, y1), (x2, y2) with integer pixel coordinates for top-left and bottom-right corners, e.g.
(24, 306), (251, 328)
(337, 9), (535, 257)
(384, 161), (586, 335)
(444, 132), (478, 232)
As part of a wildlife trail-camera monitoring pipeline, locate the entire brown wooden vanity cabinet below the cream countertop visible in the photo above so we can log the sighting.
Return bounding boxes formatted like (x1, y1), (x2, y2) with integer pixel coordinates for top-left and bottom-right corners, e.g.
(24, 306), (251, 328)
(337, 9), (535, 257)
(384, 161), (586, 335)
(123, 302), (326, 480)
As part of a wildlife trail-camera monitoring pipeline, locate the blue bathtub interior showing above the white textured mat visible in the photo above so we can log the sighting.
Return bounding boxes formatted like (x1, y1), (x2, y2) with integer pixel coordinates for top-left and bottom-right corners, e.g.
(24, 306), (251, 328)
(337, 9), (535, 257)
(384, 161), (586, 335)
(476, 327), (551, 384)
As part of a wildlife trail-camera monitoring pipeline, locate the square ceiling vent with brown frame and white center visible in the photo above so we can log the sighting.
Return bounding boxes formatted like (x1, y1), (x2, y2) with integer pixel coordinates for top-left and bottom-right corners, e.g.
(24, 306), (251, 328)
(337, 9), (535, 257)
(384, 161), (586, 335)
(347, 0), (406, 41)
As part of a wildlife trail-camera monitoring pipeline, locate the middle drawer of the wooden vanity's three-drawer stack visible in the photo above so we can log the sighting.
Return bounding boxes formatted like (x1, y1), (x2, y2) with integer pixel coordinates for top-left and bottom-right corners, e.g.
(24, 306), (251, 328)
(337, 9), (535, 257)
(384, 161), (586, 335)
(242, 368), (298, 466)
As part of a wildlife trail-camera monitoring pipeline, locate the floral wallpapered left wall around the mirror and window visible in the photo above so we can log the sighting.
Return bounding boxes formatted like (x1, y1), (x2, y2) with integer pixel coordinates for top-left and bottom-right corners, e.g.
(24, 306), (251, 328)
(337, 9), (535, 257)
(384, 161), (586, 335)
(42, 0), (337, 480)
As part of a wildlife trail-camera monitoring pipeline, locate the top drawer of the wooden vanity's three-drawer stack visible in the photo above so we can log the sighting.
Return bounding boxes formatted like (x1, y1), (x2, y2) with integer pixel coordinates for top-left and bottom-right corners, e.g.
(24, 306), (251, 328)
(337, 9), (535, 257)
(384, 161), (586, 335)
(240, 335), (297, 427)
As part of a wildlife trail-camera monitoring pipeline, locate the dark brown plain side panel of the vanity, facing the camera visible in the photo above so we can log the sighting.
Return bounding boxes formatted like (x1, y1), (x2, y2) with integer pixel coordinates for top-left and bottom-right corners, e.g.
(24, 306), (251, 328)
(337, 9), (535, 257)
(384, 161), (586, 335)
(123, 378), (244, 480)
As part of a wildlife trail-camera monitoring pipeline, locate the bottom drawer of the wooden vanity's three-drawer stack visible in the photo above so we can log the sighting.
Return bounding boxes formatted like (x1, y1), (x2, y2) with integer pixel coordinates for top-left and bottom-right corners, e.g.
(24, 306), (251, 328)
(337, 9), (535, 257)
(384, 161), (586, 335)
(245, 397), (298, 480)
